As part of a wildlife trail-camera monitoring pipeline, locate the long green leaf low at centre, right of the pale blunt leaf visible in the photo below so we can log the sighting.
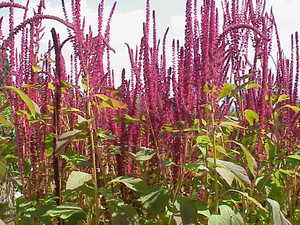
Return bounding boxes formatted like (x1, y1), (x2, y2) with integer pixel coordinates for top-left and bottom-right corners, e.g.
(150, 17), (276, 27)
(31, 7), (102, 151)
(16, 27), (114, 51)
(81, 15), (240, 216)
(109, 176), (149, 192)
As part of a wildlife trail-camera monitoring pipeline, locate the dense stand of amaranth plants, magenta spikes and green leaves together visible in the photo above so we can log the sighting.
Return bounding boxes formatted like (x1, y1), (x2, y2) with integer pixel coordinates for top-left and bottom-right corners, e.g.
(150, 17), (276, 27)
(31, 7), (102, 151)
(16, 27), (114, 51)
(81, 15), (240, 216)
(0, 0), (300, 225)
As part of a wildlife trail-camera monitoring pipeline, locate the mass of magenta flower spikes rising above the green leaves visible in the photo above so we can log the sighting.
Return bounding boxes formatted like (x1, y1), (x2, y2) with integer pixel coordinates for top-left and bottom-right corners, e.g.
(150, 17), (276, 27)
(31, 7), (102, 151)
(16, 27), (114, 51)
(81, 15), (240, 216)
(0, 0), (299, 200)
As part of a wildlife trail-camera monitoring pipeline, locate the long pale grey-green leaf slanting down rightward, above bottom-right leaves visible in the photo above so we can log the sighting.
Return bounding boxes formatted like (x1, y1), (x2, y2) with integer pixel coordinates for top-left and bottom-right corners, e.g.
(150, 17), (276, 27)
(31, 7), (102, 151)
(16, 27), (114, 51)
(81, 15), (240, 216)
(207, 158), (251, 185)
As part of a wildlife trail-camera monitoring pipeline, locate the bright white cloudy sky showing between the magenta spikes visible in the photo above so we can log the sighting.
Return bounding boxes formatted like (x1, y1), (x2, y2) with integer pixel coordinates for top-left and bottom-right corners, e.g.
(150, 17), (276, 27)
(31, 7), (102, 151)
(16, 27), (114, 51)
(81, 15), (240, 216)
(0, 0), (300, 85)
